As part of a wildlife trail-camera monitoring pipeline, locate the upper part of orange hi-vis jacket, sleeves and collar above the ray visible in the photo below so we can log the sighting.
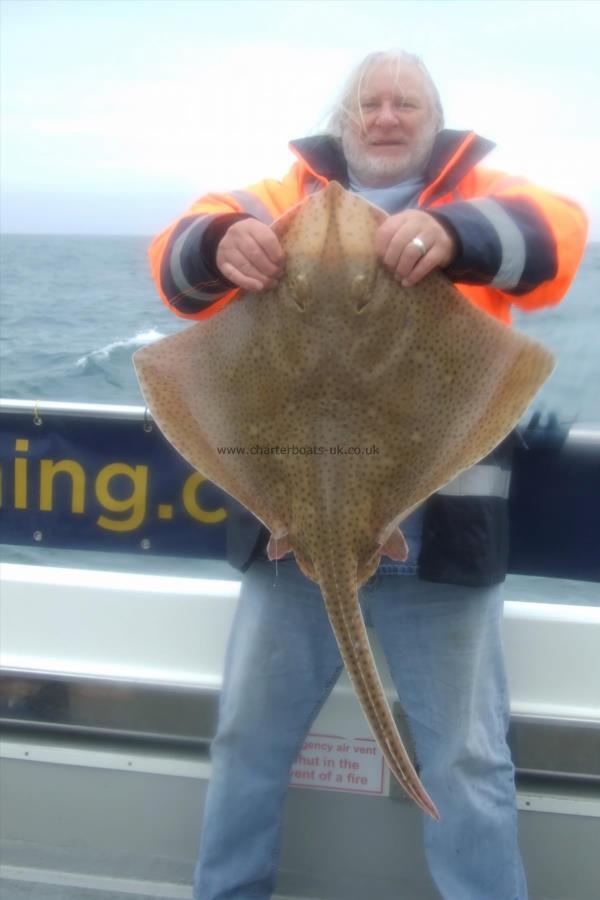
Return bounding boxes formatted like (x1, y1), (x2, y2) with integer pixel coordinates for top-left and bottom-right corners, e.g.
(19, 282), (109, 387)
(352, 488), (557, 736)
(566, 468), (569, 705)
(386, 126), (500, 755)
(149, 130), (587, 323)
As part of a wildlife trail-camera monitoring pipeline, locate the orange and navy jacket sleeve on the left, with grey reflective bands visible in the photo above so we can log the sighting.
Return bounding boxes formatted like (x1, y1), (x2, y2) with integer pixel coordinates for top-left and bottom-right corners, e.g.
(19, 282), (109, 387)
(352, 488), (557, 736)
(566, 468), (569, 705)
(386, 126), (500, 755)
(148, 164), (300, 319)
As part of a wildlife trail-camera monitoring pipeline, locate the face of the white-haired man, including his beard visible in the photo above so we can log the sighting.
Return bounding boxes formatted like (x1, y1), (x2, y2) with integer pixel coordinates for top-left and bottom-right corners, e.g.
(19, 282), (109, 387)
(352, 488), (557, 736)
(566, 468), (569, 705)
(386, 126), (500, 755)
(342, 63), (436, 187)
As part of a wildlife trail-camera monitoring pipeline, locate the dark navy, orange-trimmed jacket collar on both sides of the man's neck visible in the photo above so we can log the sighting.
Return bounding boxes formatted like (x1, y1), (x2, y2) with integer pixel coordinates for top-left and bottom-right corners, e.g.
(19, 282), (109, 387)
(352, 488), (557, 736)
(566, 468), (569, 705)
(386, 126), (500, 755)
(290, 128), (496, 202)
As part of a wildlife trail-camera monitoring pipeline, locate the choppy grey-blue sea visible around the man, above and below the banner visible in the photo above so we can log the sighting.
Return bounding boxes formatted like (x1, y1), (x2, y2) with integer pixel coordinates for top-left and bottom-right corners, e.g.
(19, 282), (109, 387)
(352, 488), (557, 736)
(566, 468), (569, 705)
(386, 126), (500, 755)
(0, 234), (600, 604)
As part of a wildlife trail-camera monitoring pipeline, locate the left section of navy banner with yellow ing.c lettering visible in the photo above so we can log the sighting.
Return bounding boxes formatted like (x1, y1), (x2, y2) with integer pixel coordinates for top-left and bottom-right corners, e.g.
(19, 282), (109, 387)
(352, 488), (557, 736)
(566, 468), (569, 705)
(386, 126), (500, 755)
(0, 412), (227, 559)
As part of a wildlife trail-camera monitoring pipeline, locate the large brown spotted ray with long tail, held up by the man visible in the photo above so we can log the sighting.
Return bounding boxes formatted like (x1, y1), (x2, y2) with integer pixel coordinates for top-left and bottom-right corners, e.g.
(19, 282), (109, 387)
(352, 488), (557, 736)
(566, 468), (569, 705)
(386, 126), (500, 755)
(133, 182), (554, 820)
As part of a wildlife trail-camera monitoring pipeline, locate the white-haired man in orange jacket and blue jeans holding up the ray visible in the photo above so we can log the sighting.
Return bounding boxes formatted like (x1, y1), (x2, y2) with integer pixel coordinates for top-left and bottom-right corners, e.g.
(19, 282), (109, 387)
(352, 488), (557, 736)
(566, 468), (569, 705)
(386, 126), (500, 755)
(150, 52), (586, 900)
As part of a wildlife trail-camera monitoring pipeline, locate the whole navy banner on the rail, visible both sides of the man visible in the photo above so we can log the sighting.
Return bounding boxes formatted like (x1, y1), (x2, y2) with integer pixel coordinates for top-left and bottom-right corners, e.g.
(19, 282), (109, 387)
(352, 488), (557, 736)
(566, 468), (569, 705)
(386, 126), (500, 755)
(0, 411), (600, 581)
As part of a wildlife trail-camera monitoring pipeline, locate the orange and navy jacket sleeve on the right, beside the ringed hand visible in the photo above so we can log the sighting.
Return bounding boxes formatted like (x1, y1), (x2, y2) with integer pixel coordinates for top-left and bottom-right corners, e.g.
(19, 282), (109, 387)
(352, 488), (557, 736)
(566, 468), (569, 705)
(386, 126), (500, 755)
(428, 167), (588, 310)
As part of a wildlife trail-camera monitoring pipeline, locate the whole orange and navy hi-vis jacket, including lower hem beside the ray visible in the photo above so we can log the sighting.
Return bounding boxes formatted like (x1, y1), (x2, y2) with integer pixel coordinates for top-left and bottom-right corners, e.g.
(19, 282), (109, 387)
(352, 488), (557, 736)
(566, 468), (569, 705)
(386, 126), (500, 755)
(150, 131), (587, 586)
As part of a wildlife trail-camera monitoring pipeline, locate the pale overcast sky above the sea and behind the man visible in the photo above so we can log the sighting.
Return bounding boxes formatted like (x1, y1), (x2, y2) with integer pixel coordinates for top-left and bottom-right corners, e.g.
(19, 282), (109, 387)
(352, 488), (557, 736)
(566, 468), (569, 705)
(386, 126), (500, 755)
(0, 0), (600, 240)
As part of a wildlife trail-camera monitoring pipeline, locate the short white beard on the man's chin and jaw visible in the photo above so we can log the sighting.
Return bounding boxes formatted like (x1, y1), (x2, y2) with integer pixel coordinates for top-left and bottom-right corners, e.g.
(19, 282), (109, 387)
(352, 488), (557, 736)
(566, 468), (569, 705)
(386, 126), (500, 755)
(342, 127), (436, 187)
